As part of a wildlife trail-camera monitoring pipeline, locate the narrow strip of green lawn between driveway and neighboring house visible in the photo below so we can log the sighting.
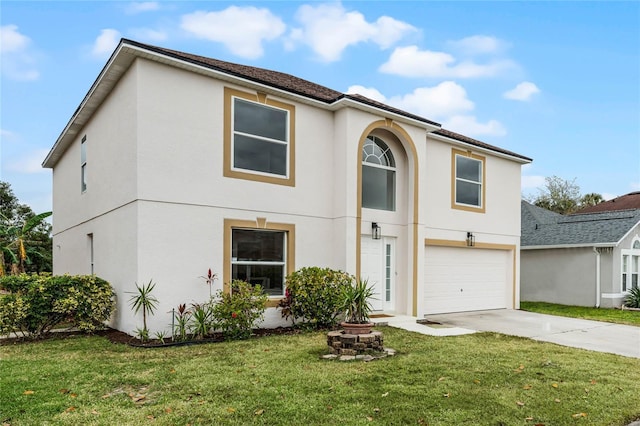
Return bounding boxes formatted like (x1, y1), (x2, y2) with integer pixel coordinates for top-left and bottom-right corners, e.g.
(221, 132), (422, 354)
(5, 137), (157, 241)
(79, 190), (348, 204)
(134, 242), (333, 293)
(520, 302), (640, 326)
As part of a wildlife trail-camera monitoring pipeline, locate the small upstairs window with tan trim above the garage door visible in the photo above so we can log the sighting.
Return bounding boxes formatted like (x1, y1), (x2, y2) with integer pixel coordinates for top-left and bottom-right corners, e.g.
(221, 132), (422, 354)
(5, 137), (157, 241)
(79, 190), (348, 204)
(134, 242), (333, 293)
(451, 149), (486, 213)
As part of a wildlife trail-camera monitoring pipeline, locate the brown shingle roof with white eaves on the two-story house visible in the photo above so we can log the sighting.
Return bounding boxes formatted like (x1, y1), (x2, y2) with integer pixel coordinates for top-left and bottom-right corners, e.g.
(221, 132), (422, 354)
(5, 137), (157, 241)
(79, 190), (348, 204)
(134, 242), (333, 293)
(43, 39), (532, 168)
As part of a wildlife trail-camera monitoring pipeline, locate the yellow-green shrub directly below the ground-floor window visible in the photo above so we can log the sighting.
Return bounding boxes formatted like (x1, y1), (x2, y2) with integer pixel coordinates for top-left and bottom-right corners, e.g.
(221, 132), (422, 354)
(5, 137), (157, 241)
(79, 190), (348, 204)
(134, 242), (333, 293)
(211, 280), (267, 339)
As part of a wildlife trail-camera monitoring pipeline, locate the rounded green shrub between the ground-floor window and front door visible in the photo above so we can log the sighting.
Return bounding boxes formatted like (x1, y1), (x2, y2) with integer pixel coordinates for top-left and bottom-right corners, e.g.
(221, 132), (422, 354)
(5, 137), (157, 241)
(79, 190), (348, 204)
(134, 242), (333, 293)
(278, 267), (354, 329)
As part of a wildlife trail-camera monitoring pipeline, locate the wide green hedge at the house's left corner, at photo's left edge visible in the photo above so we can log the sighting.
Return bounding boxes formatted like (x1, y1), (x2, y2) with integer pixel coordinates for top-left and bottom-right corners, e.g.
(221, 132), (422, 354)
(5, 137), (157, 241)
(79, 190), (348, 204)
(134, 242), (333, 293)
(0, 273), (114, 338)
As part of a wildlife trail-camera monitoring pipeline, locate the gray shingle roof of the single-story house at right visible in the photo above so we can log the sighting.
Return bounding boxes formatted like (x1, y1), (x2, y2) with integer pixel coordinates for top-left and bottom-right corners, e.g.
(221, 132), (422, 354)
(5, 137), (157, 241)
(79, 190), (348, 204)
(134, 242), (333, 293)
(520, 201), (640, 249)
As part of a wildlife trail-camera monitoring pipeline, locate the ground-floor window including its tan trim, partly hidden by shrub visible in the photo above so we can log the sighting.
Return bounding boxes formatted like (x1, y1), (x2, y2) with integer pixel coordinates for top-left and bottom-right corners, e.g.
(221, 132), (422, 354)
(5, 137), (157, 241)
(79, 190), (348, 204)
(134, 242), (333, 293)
(223, 219), (295, 306)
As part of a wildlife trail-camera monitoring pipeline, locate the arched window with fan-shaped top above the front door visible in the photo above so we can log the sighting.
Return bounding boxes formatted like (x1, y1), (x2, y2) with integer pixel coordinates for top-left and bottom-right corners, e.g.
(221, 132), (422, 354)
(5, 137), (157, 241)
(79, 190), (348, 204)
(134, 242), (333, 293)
(362, 136), (396, 211)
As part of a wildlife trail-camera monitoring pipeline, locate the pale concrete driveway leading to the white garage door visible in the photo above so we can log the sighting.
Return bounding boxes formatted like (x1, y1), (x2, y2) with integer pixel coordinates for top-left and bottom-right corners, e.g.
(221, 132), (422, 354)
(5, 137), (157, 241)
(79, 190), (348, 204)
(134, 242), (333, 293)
(425, 309), (640, 358)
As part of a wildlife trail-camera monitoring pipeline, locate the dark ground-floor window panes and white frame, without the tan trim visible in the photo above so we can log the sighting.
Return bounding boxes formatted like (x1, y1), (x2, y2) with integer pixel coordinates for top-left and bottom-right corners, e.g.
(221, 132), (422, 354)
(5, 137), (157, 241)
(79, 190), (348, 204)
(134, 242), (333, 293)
(231, 229), (287, 296)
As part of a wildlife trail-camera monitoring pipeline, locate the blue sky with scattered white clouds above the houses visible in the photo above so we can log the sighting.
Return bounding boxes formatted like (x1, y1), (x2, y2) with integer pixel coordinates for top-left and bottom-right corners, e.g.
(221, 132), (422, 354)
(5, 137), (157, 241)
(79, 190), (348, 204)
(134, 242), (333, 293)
(0, 0), (640, 212)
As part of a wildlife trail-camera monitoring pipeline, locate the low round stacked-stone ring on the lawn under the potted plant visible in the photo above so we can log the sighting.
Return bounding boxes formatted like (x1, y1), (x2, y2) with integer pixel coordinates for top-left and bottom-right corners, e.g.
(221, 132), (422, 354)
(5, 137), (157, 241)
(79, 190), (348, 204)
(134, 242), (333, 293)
(322, 330), (395, 361)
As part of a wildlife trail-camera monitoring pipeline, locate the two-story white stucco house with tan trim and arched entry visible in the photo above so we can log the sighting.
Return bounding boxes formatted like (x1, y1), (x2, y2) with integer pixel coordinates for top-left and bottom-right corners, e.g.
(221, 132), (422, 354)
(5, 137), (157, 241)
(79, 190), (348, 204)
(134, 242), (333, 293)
(43, 40), (531, 333)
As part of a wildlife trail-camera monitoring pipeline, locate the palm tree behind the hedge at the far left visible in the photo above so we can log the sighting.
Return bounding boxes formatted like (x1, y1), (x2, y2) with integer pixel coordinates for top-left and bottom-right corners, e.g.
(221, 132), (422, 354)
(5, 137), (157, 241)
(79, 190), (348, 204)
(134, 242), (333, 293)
(0, 212), (52, 276)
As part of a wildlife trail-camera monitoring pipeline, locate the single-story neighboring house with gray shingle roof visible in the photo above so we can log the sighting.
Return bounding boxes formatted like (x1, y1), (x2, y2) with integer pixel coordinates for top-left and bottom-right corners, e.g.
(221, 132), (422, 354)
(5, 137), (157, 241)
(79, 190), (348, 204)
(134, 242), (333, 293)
(520, 201), (640, 307)
